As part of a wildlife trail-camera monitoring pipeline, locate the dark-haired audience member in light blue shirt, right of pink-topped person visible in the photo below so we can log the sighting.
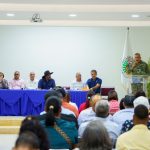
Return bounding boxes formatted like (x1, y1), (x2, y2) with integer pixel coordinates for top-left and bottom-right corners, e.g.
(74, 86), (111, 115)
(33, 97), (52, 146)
(112, 95), (135, 128)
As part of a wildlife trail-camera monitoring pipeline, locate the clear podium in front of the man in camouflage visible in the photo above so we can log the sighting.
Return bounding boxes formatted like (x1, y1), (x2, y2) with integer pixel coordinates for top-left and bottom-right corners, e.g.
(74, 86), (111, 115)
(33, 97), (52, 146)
(130, 75), (150, 95)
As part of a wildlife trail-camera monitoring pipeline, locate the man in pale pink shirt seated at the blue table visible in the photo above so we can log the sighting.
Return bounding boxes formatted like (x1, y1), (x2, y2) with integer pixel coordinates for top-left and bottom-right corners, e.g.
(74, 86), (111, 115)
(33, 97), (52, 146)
(9, 71), (25, 89)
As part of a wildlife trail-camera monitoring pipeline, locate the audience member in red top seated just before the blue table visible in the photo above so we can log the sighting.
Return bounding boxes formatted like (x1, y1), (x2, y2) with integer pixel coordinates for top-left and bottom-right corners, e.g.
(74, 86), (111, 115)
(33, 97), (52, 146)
(79, 91), (95, 113)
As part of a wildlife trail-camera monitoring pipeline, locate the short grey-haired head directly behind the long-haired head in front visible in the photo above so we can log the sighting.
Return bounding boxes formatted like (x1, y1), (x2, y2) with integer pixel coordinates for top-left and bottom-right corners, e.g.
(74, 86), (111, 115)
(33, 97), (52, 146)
(95, 100), (109, 118)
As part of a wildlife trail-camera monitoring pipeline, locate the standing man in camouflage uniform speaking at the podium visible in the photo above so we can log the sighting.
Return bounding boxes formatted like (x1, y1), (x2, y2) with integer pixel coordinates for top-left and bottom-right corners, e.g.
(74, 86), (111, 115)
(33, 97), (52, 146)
(127, 53), (149, 94)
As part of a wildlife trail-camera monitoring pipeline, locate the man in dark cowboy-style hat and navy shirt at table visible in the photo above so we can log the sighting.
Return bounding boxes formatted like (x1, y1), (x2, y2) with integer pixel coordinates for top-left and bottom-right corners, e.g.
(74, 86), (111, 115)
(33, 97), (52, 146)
(38, 70), (55, 89)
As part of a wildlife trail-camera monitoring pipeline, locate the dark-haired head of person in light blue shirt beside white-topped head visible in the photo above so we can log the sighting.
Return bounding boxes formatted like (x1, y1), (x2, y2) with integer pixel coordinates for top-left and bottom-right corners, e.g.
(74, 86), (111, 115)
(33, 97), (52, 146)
(123, 95), (135, 108)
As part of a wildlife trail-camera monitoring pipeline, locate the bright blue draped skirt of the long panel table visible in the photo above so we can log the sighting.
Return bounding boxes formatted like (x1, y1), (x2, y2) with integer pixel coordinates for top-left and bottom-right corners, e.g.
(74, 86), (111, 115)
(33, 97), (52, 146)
(0, 90), (87, 116)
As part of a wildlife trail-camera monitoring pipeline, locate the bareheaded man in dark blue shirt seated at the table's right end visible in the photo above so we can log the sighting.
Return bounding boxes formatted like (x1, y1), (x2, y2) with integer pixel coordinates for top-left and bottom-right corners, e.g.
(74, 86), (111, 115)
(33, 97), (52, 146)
(86, 70), (102, 93)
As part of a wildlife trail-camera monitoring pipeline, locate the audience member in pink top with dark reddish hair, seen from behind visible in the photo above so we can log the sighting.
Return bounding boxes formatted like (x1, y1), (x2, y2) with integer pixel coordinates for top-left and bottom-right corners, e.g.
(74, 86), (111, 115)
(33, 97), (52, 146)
(108, 90), (119, 115)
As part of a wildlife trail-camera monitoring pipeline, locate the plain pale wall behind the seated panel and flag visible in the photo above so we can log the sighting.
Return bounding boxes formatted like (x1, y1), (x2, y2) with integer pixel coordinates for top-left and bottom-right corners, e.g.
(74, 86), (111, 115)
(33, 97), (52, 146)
(0, 26), (150, 98)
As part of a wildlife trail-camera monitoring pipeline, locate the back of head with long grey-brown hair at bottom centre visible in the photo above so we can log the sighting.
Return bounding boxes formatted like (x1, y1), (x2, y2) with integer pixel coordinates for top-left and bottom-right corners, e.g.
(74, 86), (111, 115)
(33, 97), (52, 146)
(79, 121), (112, 150)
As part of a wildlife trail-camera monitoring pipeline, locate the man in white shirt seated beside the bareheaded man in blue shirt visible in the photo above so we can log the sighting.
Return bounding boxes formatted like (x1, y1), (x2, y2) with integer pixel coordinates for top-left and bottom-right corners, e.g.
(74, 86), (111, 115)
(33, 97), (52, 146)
(71, 72), (86, 90)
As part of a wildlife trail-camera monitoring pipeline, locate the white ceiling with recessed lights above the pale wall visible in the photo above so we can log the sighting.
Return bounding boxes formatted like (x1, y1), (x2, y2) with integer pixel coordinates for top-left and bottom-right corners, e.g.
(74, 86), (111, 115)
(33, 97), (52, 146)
(0, 0), (150, 26)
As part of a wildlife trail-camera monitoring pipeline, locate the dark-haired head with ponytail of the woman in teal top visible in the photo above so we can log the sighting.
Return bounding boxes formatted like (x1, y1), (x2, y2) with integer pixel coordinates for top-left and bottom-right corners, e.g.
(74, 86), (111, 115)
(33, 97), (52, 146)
(45, 96), (61, 126)
